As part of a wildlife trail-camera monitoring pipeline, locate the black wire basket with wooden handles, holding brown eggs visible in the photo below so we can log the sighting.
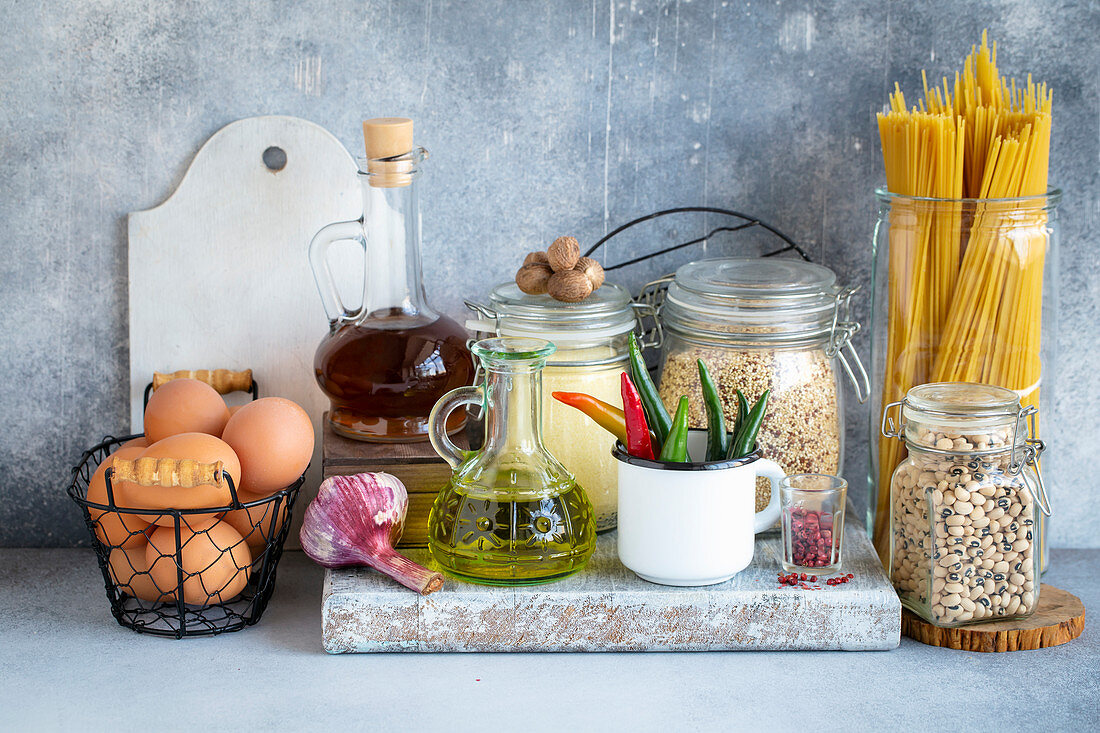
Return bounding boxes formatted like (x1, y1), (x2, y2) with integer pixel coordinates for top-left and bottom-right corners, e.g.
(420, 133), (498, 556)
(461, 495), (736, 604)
(68, 434), (305, 638)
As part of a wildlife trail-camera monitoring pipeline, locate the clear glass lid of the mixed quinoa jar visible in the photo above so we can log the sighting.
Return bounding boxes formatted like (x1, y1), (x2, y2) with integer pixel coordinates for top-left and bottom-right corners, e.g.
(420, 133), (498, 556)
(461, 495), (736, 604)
(661, 258), (842, 341)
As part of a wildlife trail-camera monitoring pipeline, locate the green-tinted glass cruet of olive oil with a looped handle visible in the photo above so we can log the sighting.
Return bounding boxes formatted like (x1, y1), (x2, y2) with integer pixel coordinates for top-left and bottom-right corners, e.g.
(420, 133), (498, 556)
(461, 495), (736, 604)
(428, 337), (596, 586)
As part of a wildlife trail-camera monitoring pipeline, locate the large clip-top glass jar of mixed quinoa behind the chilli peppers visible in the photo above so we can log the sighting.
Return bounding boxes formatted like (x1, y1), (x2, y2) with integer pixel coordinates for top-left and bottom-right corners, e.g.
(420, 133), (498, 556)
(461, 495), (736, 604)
(659, 258), (869, 511)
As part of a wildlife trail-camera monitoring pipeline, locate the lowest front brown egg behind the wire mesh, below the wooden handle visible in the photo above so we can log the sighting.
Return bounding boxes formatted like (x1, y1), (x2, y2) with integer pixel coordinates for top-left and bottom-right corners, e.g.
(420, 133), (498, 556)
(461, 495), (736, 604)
(145, 519), (252, 605)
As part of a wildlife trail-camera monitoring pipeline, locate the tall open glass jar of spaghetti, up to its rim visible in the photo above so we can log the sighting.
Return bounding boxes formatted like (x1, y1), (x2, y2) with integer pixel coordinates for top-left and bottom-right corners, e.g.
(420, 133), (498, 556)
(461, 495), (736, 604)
(868, 189), (1062, 569)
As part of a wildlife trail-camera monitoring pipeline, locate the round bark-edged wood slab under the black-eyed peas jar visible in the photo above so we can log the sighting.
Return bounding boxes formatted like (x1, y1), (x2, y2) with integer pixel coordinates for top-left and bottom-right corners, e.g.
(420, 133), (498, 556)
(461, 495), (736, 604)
(901, 584), (1085, 652)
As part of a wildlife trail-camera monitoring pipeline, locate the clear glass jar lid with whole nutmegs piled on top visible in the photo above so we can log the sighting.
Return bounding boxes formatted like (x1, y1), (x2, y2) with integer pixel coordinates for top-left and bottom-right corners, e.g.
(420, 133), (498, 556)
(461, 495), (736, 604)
(466, 283), (637, 344)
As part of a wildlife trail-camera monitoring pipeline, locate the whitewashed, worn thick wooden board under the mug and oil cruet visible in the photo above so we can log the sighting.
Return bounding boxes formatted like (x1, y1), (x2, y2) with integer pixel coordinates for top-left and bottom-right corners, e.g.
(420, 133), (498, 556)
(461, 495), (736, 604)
(321, 508), (901, 654)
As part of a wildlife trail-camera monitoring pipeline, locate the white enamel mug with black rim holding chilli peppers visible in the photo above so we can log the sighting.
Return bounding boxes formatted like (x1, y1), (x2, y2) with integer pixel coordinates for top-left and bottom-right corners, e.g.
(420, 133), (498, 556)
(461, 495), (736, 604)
(612, 430), (785, 586)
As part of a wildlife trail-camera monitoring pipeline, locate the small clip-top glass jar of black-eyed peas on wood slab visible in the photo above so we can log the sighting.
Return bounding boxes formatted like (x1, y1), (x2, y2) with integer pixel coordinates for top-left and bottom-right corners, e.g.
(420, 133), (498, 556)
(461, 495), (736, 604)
(882, 382), (1051, 626)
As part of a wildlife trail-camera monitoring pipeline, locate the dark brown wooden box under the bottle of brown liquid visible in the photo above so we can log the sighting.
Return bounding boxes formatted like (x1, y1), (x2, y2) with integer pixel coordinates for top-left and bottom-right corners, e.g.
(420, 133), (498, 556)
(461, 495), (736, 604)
(321, 413), (466, 547)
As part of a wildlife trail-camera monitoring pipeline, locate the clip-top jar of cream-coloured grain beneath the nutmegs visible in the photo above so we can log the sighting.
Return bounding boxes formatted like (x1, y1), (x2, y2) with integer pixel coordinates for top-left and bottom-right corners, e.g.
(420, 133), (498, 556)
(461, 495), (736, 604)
(466, 283), (648, 532)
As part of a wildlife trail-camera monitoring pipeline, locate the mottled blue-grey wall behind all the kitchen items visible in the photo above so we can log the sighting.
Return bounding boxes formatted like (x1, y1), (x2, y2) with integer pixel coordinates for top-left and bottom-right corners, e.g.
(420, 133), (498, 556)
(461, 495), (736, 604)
(0, 0), (1100, 547)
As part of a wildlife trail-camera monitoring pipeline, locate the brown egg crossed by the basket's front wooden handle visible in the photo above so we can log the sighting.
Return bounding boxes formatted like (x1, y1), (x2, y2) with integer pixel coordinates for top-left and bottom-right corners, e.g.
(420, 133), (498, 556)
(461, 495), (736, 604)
(119, 431), (241, 526)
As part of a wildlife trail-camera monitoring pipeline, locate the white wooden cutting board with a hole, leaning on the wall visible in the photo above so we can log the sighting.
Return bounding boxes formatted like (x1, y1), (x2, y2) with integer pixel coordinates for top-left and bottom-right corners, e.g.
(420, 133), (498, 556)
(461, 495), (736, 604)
(129, 117), (363, 537)
